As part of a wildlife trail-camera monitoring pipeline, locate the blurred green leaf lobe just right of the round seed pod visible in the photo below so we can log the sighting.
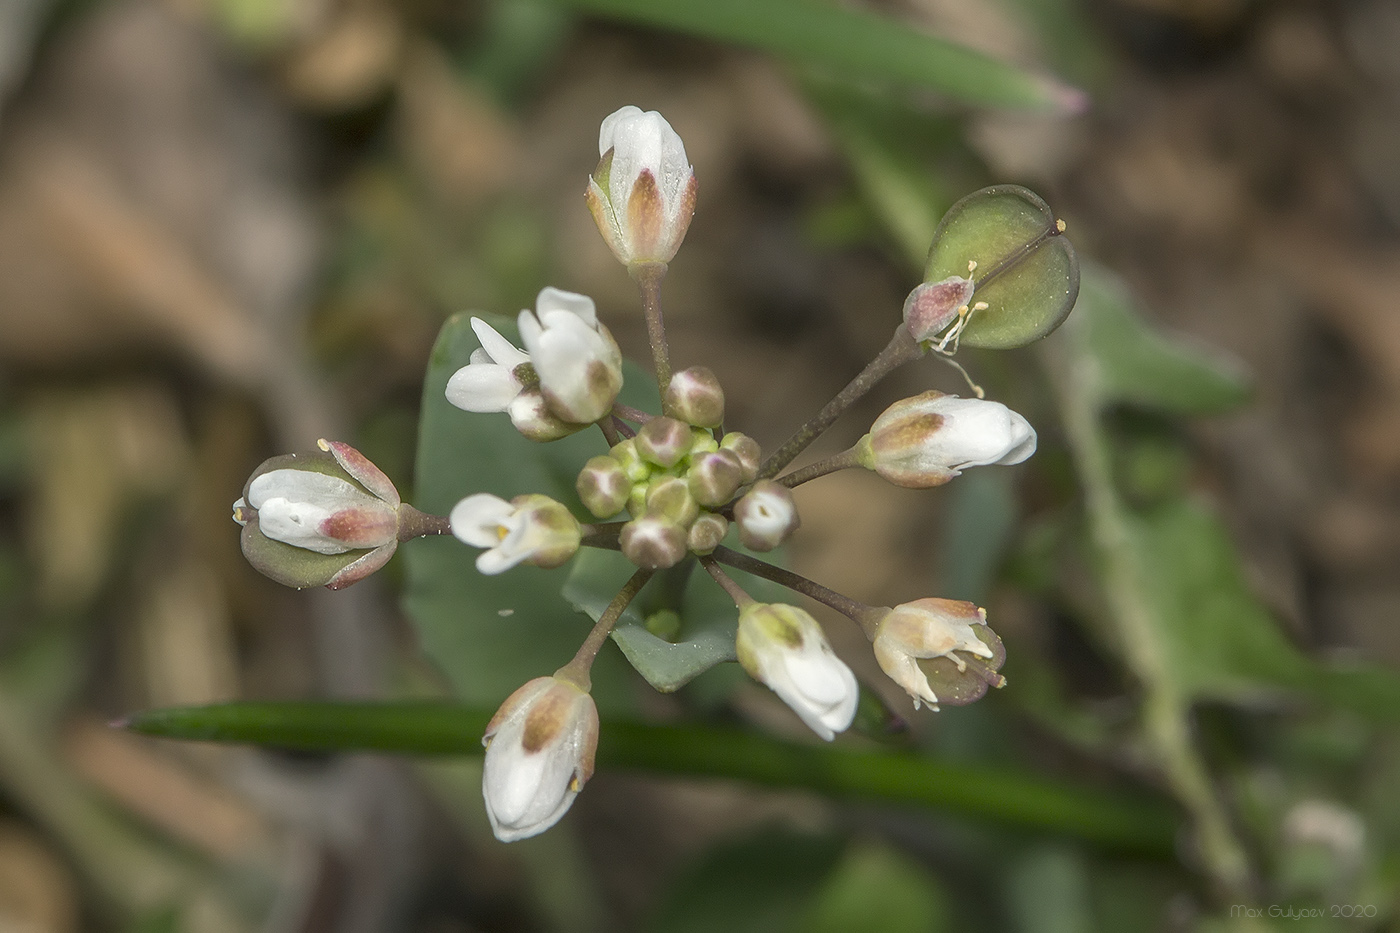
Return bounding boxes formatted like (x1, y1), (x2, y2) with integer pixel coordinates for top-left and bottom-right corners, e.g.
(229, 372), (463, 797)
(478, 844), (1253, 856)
(1077, 269), (1249, 415)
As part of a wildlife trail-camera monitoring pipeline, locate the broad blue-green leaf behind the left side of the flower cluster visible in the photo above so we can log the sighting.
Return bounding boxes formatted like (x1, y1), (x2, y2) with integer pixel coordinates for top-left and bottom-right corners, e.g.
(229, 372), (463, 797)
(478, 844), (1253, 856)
(402, 314), (658, 712)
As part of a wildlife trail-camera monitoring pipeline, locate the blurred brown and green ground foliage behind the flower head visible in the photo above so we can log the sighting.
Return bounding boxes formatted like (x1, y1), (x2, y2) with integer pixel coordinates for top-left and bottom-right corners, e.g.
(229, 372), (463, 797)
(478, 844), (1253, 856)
(0, 0), (1400, 933)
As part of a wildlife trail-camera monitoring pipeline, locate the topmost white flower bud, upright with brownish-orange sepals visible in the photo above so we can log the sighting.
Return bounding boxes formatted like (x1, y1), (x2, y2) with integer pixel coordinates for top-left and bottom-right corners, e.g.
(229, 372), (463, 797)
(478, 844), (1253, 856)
(587, 105), (696, 265)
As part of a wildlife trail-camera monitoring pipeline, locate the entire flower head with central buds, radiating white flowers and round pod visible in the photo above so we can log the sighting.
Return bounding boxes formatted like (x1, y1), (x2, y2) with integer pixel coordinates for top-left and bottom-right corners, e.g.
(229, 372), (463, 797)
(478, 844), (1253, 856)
(234, 106), (1078, 842)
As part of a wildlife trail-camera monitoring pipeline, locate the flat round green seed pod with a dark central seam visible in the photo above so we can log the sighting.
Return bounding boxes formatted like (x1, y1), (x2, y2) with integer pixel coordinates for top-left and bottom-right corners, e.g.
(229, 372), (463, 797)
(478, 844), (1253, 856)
(924, 185), (1079, 349)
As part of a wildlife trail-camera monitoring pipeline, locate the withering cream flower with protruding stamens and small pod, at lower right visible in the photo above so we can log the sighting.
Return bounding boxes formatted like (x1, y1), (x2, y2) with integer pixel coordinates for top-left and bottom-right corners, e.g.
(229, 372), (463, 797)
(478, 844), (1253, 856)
(872, 598), (1007, 709)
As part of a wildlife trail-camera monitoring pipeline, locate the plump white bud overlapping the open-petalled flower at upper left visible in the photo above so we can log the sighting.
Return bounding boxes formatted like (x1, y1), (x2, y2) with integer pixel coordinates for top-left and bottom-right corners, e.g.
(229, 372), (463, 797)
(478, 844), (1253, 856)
(518, 282), (622, 424)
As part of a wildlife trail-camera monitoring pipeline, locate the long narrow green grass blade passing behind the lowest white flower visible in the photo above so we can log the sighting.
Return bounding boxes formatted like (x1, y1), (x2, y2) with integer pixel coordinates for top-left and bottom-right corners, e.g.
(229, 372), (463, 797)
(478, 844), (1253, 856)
(126, 700), (1176, 856)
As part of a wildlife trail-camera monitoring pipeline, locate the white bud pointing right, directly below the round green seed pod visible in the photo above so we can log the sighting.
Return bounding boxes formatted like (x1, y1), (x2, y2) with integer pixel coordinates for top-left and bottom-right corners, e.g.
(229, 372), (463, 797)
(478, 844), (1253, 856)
(855, 392), (1036, 489)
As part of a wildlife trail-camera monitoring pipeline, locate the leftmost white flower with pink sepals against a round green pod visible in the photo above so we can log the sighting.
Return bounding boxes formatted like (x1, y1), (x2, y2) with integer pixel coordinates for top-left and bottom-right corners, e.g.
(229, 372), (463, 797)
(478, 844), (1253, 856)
(234, 440), (406, 590)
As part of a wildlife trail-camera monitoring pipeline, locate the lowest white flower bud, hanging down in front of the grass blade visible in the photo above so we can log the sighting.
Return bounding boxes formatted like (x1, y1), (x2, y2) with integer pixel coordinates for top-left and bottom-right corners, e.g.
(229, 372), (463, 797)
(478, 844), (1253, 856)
(482, 677), (598, 842)
